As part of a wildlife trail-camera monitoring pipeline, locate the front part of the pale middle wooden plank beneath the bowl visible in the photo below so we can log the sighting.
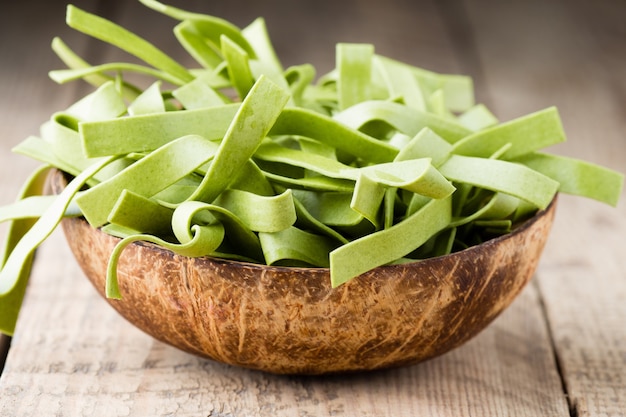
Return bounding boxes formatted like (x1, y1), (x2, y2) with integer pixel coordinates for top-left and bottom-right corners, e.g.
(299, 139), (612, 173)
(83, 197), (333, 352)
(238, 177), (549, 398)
(0, 233), (568, 417)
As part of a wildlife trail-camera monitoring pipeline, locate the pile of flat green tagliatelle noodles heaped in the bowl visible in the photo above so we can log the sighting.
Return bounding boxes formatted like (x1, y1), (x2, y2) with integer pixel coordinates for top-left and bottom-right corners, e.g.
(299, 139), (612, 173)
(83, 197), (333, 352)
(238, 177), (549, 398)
(0, 0), (623, 334)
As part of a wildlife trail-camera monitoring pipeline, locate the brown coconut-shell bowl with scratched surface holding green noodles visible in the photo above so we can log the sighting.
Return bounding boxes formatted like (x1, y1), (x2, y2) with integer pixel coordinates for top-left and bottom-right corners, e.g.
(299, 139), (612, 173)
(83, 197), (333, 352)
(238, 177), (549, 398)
(52, 172), (556, 374)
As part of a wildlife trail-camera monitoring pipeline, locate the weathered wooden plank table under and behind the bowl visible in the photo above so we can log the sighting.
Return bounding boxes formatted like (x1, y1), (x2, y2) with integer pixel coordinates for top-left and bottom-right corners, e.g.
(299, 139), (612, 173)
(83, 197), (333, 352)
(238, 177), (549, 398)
(0, 0), (626, 417)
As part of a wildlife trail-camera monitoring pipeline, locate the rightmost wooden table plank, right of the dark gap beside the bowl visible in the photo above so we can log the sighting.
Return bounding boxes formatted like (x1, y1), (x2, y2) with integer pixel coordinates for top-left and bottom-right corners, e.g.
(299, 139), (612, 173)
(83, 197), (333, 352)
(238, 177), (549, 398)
(465, 1), (626, 416)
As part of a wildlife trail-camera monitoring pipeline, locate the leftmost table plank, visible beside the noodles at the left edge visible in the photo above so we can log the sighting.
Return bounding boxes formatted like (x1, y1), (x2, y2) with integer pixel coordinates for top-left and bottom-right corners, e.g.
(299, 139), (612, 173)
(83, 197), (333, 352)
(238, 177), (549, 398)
(0, 2), (84, 378)
